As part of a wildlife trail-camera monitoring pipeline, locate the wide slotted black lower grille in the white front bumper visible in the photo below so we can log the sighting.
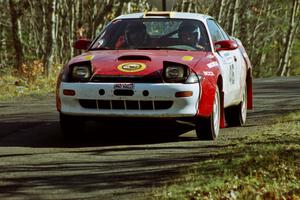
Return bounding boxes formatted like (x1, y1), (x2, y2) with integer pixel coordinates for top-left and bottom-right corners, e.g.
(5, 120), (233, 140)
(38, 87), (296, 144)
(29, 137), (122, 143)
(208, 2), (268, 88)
(79, 99), (173, 110)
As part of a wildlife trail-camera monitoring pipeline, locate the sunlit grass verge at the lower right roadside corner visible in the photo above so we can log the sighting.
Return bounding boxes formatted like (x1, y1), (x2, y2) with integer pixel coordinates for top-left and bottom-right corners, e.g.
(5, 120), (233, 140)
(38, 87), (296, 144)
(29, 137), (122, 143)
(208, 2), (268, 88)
(150, 112), (300, 200)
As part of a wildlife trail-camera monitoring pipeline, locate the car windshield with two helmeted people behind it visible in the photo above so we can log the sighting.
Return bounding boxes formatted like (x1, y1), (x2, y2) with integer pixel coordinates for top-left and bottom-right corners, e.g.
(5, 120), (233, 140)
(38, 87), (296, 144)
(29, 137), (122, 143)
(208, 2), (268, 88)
(90, 18), (211, 51)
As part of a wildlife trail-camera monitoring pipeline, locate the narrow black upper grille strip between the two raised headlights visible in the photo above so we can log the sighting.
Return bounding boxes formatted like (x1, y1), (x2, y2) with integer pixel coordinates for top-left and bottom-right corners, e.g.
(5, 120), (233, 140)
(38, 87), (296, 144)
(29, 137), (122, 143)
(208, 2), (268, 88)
(91, 75), (163, 83)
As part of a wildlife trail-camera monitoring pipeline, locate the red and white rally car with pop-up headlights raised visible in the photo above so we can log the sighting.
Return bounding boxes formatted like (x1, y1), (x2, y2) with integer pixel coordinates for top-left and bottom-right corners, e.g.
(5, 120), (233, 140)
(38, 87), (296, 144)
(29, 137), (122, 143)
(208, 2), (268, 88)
(56, 12), (252, 140)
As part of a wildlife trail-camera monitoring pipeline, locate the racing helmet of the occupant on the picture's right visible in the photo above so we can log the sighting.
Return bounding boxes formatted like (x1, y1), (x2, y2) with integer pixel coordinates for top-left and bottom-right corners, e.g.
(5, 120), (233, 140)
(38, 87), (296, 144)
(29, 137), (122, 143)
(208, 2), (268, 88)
(178, 22), (201, 45)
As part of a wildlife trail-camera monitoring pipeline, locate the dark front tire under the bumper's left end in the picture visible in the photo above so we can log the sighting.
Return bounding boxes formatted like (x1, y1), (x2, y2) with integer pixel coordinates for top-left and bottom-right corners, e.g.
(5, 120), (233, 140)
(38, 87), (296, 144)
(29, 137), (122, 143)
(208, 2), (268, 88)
(59, 113), (85, 140)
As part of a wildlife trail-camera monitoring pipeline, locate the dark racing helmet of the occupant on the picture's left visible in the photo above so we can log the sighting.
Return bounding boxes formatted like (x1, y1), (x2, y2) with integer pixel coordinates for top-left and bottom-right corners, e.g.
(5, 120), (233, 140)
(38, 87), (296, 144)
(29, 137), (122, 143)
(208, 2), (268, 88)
(125, 21), (147, 46)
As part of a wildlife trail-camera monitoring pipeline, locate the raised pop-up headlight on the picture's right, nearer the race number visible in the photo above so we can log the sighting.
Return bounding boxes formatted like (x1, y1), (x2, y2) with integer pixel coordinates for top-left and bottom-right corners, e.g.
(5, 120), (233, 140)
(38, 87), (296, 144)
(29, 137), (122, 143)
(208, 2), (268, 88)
(163, 65), (187, 83)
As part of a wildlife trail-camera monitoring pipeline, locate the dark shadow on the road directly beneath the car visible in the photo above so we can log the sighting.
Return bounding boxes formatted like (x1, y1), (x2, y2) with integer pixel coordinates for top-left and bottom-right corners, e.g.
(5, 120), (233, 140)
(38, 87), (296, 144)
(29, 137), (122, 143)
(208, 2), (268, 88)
(0, 121), (196, 148)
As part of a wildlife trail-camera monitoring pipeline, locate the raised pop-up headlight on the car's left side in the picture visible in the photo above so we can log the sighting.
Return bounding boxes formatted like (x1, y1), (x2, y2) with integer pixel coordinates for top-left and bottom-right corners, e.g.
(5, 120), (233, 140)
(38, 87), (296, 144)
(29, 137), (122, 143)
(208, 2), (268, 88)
(71, 65), (91, 82)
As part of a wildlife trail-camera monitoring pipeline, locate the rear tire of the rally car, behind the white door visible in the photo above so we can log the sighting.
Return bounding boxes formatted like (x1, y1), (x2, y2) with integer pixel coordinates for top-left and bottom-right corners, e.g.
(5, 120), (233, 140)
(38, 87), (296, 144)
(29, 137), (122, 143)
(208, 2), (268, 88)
(225, 85), (247, 127)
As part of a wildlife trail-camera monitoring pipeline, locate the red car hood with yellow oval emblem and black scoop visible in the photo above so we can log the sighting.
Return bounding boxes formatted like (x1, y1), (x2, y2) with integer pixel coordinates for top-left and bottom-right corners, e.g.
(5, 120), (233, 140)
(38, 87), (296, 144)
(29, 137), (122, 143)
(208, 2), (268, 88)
(69, 50), (208, 76)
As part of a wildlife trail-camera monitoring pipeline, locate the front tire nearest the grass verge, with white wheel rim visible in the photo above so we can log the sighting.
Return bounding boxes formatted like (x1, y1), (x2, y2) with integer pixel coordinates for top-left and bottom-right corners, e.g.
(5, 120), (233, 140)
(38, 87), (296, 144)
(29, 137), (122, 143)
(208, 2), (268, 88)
(196, 88), (221, 140)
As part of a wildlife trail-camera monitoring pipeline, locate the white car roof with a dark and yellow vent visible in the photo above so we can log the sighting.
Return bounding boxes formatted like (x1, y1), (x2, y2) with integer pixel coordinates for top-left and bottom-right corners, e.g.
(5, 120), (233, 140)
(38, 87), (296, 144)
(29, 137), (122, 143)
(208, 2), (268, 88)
(115, 11), (212, 21)
